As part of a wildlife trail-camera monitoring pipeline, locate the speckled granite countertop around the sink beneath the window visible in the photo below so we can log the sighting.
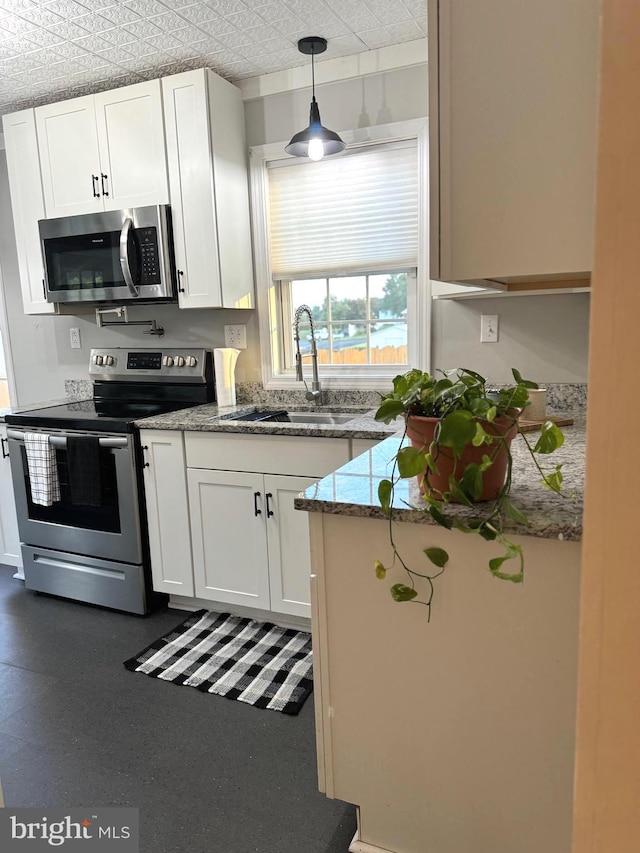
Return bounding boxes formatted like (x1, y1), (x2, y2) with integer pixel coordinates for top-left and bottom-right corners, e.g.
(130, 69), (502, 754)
(135, 403), (398, 439)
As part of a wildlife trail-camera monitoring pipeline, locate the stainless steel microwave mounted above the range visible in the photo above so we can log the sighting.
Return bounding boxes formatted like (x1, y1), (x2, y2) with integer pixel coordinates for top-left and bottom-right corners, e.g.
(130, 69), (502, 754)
(38, 205), (176, 302)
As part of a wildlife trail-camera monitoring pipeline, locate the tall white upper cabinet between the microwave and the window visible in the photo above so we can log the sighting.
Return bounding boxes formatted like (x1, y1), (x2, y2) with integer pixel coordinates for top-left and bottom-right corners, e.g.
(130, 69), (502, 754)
(162, 69), (254, 308)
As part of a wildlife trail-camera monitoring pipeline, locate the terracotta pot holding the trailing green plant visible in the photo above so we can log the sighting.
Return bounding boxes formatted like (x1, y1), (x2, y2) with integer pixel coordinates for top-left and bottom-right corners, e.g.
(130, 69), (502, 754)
(407, 415), (518, 501)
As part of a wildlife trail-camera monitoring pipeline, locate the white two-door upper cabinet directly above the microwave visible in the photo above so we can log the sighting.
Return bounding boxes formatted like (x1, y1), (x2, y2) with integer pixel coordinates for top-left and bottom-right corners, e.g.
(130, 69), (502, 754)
(35, 80), (169, 218)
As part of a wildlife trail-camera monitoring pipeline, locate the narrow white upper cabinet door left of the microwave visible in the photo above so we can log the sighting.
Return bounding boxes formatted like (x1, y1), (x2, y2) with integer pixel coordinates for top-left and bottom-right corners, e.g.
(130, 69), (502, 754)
(3, 110), (55, 314)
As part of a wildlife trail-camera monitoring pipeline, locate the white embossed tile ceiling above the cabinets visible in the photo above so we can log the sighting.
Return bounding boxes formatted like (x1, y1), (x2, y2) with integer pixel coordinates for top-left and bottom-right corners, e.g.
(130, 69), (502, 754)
(0, 0), (427, 115)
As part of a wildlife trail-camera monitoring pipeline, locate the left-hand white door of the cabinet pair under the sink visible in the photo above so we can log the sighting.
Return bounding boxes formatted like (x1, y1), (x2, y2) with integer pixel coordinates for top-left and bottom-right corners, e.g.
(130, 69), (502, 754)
(187, 468), (269, 610)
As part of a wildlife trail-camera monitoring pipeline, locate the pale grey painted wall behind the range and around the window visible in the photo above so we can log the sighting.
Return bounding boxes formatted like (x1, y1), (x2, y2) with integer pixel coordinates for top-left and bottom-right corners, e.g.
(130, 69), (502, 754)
(0, 60), (588, 404)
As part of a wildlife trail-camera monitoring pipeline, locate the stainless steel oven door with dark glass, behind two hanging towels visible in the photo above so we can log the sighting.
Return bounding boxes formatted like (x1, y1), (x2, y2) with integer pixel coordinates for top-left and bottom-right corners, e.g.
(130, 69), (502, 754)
(7, 428), (142, 564)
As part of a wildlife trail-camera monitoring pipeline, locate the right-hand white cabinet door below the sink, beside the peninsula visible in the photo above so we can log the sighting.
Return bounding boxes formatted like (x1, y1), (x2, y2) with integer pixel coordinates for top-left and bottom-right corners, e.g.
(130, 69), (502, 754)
(264, 474), (316, 617)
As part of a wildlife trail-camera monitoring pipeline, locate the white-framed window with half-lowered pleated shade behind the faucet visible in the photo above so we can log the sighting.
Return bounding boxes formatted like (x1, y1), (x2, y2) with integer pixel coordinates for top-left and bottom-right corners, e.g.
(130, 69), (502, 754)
(252, 121), (428, 388)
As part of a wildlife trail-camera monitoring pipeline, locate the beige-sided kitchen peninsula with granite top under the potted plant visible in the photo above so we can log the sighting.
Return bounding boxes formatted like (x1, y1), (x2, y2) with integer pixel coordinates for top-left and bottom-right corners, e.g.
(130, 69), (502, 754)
(296, 422), (585, 853)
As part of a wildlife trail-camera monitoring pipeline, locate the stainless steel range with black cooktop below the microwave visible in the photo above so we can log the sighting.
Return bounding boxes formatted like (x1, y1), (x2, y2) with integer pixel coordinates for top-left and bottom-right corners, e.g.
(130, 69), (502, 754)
(6, 348), (215, 614)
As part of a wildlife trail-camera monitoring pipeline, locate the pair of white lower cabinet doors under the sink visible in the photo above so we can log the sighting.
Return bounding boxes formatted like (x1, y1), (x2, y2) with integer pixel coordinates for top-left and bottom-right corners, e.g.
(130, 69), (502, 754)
(187, 468), (314, 616)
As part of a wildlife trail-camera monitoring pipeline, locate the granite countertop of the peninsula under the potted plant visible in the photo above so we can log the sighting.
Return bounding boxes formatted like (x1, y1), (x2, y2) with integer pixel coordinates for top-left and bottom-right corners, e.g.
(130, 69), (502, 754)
(295, 417), (586, 541)
